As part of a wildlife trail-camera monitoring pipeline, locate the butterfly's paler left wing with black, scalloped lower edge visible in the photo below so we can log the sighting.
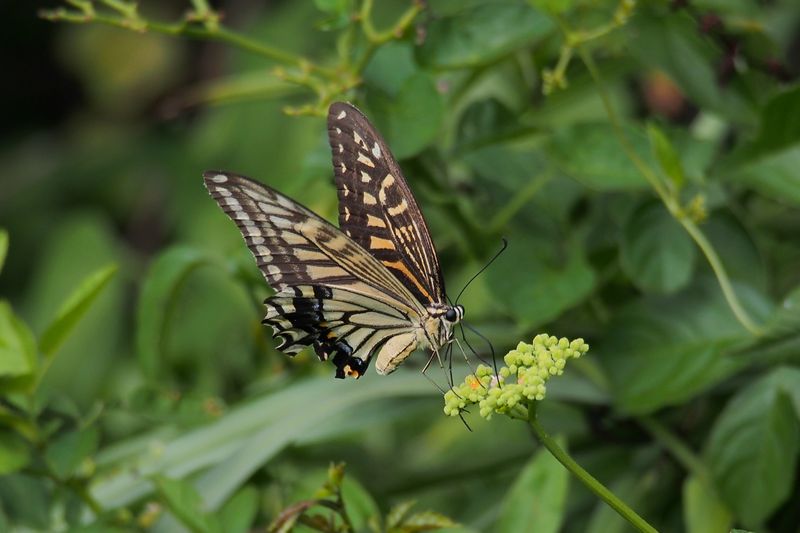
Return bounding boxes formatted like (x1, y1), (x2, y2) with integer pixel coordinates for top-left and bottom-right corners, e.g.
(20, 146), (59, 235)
(203, 171), (424, 377)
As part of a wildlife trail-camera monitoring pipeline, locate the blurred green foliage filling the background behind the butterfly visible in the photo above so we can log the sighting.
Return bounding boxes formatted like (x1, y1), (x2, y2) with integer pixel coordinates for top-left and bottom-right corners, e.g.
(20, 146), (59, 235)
(0, 0), (800, 533)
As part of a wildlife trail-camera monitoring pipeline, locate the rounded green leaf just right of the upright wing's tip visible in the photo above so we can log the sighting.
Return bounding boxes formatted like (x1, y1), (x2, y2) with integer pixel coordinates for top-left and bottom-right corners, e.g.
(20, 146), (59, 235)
(368, 73), (444, 159)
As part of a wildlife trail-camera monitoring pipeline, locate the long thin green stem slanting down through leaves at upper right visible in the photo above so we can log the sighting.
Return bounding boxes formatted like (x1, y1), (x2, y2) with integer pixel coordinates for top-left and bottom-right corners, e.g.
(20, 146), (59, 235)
(559, 21), (762, 336)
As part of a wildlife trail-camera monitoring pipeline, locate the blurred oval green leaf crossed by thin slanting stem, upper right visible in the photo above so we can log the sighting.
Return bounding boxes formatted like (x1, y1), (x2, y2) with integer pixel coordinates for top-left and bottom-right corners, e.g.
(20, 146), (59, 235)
(550, 122), (654, 191)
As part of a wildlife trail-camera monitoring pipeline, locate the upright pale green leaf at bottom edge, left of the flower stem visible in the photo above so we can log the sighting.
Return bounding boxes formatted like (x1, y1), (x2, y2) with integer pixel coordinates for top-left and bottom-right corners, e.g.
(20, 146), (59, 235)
(495, 439), (569, 533)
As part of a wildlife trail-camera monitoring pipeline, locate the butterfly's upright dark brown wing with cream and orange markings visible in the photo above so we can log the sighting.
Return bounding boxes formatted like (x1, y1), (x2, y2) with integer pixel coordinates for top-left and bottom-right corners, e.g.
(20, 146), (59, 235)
(328, 102), (444, 305)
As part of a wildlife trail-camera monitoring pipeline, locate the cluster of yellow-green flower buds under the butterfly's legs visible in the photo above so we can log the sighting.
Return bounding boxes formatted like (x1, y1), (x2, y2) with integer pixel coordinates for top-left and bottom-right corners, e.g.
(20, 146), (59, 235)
(444, 334), (589, 420)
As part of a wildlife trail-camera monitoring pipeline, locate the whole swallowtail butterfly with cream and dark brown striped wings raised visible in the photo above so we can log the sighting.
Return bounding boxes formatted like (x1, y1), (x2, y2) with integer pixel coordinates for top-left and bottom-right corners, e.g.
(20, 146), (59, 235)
(203, 102), (464, 378)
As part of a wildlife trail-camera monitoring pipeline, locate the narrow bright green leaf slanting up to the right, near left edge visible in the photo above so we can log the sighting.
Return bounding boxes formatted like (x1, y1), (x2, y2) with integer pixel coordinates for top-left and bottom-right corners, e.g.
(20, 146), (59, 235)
(39, 265), (118, 357)
